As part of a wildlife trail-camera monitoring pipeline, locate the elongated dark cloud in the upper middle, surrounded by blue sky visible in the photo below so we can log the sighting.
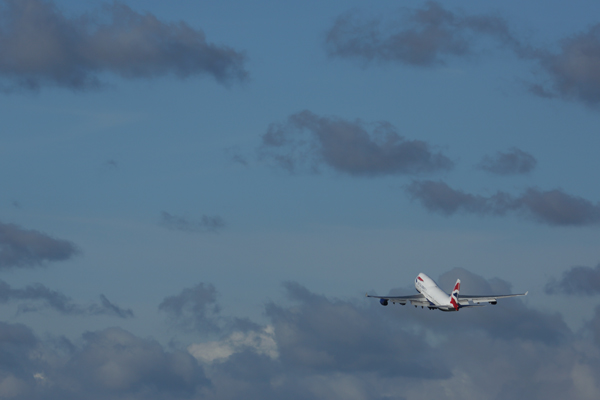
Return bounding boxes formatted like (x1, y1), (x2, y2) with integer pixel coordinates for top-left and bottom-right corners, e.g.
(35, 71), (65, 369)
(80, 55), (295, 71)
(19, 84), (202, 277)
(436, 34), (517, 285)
(260, 110), (453, 176)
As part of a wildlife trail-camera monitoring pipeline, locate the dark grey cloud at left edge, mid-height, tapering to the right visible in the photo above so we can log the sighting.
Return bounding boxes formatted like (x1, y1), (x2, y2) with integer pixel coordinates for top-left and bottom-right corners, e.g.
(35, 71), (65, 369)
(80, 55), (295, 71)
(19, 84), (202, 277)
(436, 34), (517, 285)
(0, 222), (78, 270)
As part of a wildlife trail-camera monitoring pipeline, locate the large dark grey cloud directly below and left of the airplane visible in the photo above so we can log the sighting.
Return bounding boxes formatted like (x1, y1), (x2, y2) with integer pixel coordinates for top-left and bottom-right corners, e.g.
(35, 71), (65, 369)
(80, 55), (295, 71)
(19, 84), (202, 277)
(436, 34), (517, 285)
(266, 282), (451, 379)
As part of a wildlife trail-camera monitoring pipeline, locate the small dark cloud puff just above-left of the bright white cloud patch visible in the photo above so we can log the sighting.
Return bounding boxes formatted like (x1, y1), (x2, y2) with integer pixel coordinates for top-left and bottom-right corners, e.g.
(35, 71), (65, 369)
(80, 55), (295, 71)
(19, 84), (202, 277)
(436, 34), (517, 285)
(158, 283), (221, 332)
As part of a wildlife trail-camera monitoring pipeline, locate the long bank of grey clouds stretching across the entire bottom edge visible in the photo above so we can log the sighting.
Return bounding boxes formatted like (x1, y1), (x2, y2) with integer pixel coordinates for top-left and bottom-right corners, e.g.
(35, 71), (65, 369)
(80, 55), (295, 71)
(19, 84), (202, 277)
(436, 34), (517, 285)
(0, 276), (600, 400)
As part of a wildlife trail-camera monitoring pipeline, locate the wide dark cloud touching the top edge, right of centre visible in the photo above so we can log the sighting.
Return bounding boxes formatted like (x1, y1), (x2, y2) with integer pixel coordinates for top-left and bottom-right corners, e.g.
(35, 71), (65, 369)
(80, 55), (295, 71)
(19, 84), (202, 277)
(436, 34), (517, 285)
(326, 1), (521, 67)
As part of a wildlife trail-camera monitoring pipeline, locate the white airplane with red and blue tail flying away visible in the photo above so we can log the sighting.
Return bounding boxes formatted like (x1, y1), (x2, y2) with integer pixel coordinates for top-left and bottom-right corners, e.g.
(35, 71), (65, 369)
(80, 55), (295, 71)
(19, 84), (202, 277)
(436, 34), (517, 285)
(367, 272), (529, 311)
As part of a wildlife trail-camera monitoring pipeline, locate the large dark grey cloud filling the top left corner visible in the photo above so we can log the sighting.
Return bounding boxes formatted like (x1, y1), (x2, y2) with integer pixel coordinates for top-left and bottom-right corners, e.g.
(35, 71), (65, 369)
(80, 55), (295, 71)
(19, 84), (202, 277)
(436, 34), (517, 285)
(0, 0), (247, 90)
